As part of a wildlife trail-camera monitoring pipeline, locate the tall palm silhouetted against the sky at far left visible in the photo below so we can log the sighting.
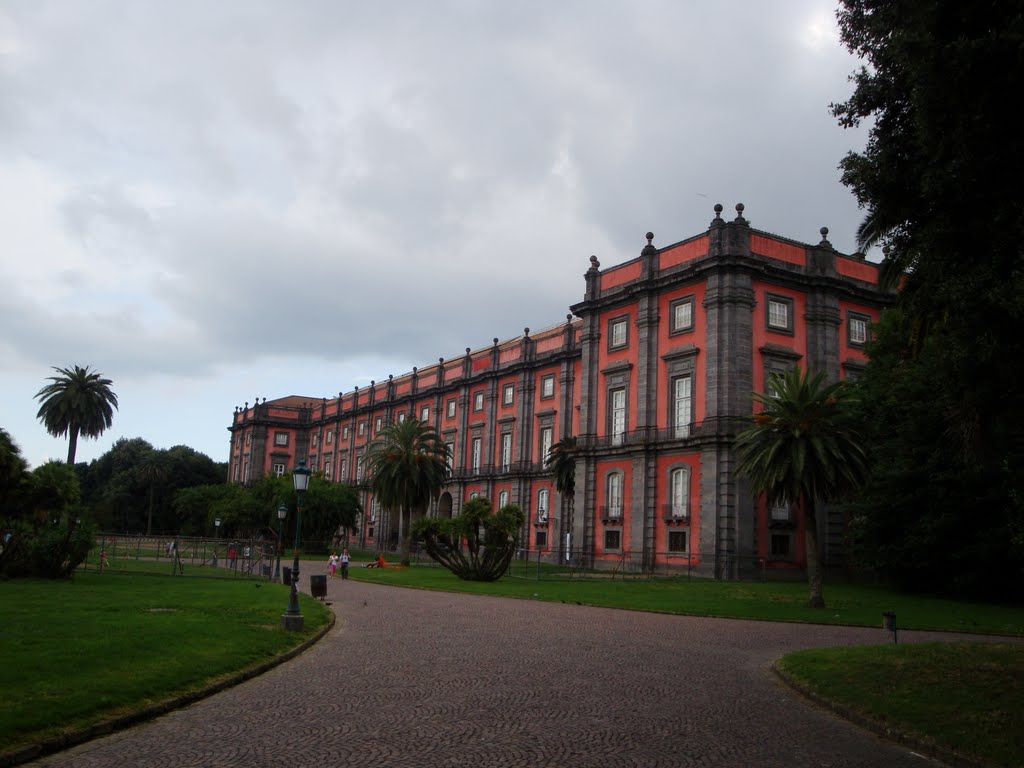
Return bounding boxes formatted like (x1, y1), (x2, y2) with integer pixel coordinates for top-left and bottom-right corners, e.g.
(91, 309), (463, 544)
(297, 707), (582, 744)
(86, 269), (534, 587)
(36, 366), (118, 464)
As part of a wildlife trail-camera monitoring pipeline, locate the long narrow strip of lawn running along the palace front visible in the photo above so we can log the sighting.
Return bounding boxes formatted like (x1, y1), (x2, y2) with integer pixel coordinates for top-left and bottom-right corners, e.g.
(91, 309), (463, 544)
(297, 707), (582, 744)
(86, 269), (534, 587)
(349, 565), (1024, 636)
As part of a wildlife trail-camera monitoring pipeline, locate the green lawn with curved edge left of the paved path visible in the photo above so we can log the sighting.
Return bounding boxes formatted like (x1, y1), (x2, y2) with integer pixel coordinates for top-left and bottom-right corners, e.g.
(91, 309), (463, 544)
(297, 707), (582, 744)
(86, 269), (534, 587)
(0, 563), (330, 752)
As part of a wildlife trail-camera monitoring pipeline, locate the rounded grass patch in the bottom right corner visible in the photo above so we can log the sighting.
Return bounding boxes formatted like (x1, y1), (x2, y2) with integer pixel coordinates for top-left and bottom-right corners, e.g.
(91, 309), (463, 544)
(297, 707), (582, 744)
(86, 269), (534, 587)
(776, 643), (1024, 768)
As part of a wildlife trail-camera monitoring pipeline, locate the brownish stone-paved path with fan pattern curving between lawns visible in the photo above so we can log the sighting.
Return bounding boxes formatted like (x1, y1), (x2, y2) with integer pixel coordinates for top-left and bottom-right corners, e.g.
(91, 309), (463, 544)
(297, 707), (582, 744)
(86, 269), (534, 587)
(32, 580), (966, 768)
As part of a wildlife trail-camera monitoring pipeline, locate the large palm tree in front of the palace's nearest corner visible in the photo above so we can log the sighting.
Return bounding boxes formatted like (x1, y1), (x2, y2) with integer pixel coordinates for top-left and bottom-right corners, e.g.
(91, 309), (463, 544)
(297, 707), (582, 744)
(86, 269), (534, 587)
(736, 367), (868, 608)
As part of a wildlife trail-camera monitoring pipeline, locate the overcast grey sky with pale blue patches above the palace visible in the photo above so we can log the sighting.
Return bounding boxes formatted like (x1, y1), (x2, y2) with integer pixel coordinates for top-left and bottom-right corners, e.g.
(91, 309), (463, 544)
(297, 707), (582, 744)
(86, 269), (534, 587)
(0, 0), (864, 465)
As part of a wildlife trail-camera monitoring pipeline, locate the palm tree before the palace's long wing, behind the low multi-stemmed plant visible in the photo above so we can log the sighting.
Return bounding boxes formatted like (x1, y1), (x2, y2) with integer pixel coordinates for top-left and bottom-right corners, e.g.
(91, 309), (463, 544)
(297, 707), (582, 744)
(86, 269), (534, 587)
(365, 419), (450, 564)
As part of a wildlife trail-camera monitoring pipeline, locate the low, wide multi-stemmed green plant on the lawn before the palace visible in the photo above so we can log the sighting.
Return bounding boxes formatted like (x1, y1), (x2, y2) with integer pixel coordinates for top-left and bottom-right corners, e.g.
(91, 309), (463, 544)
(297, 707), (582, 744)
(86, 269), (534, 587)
(413, 497), (526, 582)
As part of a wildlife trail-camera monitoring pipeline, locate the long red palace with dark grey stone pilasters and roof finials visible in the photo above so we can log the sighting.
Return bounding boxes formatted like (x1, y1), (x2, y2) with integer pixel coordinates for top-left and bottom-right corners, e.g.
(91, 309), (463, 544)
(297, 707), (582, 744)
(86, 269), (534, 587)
(229, 205), (891, 578)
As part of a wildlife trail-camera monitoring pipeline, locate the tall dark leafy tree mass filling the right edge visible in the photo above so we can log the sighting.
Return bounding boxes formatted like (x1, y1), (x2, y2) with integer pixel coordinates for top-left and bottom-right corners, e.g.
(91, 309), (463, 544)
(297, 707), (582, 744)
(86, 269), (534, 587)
(834, 0), (1024, 597)
